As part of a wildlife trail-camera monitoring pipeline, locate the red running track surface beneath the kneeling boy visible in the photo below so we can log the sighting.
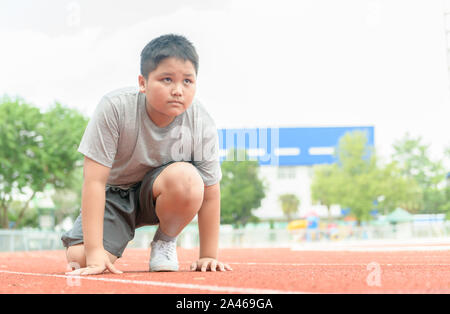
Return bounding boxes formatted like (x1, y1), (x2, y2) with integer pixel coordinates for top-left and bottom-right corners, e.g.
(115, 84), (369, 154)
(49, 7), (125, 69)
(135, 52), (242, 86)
(0, 248), (450, 294)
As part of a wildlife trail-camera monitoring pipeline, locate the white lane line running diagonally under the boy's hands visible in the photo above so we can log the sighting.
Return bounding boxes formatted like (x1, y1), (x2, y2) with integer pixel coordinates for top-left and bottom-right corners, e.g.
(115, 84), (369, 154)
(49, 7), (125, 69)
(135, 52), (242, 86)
(0, 270), (310, 294)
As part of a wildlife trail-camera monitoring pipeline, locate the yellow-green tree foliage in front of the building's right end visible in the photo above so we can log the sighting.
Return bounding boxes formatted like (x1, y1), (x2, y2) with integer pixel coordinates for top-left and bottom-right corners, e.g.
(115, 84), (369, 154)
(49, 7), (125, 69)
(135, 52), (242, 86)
(311, 131), (420, 223)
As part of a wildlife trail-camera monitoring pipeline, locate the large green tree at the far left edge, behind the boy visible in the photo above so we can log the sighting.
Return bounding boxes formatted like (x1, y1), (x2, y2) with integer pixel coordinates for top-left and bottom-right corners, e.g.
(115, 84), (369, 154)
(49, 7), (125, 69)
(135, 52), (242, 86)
(0, 96), (87, 228)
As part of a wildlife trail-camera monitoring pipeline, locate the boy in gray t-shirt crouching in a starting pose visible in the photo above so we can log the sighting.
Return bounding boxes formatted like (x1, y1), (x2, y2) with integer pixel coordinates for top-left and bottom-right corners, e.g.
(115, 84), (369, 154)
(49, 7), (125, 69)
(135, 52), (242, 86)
(61, 34), (231, 275)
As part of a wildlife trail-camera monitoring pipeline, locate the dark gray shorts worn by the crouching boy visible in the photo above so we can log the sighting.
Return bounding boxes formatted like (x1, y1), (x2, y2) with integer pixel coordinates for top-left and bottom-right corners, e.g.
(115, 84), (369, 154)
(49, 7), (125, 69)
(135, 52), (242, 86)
(61, 162), (179, 258)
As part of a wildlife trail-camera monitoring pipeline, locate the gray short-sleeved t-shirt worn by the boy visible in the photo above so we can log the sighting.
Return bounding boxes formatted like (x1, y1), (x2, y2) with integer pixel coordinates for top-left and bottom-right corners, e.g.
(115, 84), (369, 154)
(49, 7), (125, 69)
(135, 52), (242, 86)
(78, 88), (222, 188)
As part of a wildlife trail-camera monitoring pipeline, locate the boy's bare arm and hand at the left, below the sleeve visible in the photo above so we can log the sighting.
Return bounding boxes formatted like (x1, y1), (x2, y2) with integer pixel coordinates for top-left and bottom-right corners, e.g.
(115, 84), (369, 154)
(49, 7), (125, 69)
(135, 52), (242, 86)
(69, 157), (120, 275)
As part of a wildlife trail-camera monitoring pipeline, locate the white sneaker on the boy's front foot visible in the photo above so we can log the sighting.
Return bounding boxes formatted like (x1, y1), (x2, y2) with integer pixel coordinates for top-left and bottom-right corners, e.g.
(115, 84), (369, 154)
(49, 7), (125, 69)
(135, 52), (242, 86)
(150, 240), (178, 271)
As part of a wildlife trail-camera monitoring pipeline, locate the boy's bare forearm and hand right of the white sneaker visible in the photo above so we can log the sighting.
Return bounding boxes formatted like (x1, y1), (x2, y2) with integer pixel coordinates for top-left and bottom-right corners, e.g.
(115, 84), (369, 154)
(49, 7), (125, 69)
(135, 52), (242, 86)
(192, 183), (231, 271)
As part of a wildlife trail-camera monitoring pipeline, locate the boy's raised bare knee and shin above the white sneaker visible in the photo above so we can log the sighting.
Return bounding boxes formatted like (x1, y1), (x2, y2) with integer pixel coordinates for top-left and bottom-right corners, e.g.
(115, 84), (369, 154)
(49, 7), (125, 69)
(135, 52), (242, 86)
(153, 162), (204, 237)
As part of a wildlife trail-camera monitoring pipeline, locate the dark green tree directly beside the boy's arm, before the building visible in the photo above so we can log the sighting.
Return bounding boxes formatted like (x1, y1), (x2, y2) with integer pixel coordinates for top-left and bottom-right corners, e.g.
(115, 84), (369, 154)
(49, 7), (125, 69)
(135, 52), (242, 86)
(220, 150), (265, 227)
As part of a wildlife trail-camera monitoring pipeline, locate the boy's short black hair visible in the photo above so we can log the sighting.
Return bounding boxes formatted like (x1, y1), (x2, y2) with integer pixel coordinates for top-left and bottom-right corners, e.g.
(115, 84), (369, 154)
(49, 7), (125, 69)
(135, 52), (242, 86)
(141, 34), (198, 79)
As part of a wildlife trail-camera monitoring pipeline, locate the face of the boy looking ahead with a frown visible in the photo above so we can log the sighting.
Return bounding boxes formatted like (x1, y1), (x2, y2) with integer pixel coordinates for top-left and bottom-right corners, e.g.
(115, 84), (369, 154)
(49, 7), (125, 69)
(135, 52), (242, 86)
(139, 57), (197, 127)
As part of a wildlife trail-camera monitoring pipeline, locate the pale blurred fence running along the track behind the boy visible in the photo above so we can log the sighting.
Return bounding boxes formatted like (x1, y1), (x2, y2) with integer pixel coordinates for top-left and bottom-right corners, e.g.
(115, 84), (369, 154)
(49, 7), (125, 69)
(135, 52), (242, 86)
(0, 221), (450, 251)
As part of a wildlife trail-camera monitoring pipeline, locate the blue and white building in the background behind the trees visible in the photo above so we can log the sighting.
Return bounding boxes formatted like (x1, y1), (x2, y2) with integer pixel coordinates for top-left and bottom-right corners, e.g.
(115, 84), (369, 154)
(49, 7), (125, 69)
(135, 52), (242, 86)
(218, 126), (375, 219)
